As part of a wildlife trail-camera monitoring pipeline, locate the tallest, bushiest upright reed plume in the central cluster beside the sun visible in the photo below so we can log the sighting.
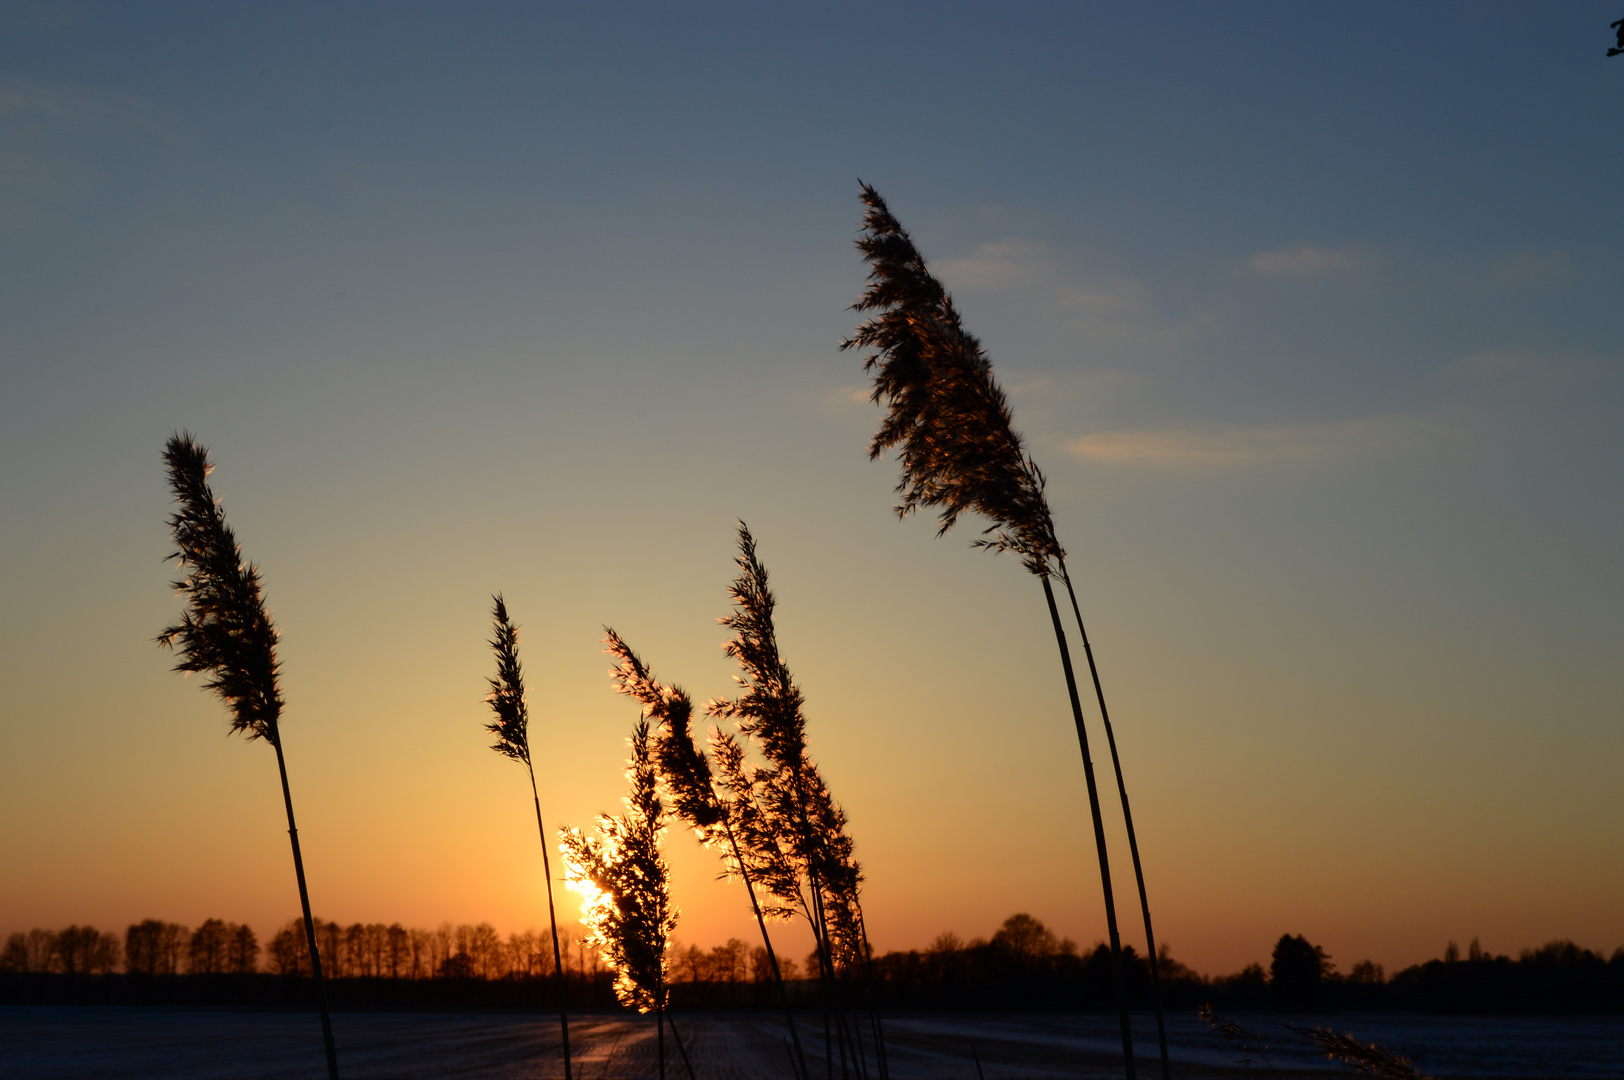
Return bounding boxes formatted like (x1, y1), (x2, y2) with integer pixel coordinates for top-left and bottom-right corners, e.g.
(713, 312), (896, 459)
(708, 523), (888, 1078)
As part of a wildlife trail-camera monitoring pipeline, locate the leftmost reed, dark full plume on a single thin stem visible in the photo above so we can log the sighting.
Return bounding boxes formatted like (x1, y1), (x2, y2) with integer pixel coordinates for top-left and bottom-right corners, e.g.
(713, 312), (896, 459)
(158, 432), (338, 1080)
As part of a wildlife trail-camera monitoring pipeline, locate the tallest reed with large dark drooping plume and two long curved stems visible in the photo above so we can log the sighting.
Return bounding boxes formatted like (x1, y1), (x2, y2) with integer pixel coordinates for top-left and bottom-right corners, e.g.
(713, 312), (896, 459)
(841, 184), (1169, 1080)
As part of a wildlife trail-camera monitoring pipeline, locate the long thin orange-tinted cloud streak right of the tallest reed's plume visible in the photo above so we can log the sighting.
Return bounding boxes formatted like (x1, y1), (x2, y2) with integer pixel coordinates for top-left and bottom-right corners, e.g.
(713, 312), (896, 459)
(1065, 414), (1458, 468)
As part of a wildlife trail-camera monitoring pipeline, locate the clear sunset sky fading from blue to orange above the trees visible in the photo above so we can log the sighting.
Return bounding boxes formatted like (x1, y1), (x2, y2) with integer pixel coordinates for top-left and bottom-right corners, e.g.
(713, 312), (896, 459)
(0, 0), (1624, 974)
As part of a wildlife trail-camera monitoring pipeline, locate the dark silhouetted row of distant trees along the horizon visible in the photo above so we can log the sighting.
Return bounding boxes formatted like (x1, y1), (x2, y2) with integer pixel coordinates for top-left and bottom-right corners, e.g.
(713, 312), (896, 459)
(0, 913), (1624, 1013)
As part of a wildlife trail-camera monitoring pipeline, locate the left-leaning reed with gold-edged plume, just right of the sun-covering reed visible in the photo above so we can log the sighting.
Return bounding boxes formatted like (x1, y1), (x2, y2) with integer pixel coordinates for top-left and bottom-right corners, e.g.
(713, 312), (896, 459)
(604, 629), (806, 1077)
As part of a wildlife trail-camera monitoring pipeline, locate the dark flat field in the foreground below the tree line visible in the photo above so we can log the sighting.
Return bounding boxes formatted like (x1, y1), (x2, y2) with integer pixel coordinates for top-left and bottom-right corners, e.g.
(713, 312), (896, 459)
(0, 1007), (1624, 1080)
